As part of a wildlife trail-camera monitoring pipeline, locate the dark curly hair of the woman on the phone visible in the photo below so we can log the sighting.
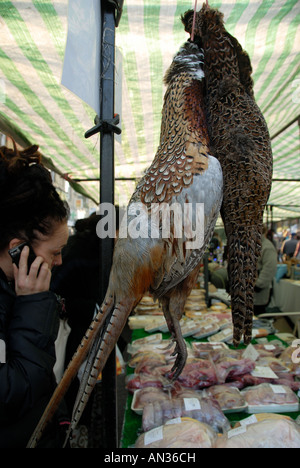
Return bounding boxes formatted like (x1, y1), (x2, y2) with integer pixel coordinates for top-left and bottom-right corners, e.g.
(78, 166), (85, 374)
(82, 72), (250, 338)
(0, 140), (69, 251)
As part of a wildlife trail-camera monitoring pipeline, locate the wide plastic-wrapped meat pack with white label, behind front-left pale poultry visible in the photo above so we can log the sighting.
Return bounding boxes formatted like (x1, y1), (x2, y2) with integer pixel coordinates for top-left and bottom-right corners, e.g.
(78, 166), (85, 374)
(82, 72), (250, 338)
(143, 397), (230, 432)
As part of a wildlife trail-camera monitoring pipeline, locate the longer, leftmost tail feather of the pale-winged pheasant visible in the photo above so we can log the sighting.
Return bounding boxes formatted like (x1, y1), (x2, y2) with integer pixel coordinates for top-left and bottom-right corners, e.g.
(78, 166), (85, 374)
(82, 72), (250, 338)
(27, 296), (113, 448)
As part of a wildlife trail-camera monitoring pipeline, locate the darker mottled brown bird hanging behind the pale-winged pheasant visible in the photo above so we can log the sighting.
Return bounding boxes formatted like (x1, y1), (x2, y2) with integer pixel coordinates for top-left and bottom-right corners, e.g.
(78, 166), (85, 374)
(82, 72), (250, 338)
(183, 4), (272, 345)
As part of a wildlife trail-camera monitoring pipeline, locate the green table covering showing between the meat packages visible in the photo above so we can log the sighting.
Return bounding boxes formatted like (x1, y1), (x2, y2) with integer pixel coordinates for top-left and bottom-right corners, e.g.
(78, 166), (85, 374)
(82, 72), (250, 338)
(120, 330), (300, 448)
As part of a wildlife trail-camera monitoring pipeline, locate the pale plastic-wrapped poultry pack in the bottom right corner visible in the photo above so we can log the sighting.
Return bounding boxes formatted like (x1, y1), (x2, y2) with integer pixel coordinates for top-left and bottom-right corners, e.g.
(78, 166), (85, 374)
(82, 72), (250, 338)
(216, 418), (300, 448)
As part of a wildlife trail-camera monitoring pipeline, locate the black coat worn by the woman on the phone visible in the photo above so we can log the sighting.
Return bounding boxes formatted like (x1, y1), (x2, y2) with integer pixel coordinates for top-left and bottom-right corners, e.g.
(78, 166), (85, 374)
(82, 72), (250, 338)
(0, 270), (67, 448)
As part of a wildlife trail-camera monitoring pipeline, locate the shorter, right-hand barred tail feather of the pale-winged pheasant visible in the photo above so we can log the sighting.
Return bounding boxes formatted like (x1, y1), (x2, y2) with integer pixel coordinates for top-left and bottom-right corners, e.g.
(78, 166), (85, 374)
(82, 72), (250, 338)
(66, 300), (134, 441)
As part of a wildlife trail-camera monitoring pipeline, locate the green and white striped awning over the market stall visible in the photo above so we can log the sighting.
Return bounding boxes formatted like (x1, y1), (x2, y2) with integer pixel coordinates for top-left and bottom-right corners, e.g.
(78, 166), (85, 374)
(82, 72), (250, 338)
(0, 0), (300, 220)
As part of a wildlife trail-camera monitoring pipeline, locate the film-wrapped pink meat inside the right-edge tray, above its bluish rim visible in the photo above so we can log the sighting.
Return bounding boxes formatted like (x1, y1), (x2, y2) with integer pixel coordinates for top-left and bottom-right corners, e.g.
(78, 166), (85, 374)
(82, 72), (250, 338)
(242, 383), (299, 406)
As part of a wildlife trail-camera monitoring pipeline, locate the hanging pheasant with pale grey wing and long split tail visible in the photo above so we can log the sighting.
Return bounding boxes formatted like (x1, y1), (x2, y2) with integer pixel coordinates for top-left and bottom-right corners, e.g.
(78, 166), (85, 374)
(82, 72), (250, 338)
(29, 37), (223, 447)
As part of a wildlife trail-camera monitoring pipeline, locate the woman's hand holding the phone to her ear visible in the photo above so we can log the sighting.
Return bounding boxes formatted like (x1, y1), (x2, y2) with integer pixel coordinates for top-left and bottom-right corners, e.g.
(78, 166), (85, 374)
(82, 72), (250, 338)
(13, 246), (51, 296)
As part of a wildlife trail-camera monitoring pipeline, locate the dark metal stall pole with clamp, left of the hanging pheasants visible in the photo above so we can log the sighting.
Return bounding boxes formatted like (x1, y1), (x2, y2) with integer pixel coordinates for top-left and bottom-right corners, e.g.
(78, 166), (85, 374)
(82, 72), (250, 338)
(85, 0), (123, 448)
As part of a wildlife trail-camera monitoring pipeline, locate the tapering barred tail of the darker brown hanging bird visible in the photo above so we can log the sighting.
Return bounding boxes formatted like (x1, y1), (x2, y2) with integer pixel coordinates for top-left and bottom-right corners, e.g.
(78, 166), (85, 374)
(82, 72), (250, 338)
(228, 227), (260, 346)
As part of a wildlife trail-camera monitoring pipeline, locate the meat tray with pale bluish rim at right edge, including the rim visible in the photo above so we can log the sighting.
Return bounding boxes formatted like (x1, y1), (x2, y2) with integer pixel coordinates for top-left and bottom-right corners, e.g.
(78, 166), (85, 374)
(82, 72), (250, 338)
(241, 383), (299, 413)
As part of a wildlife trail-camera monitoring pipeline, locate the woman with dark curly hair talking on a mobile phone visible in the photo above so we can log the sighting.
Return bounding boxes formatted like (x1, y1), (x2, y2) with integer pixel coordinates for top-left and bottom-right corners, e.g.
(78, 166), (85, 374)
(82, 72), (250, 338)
(0, 141), (69, 448)
